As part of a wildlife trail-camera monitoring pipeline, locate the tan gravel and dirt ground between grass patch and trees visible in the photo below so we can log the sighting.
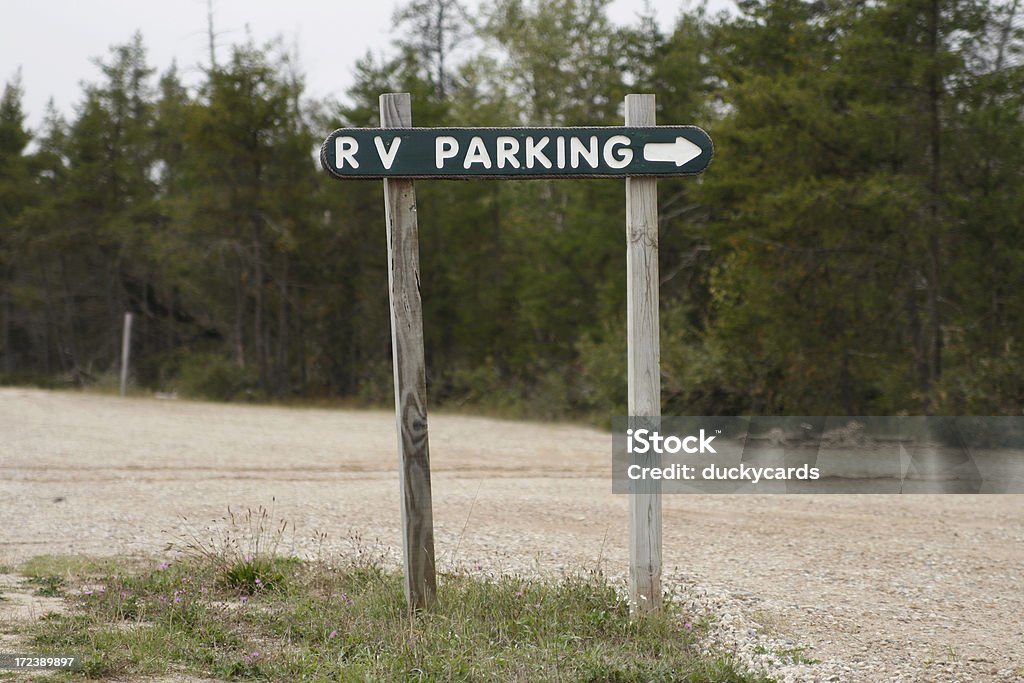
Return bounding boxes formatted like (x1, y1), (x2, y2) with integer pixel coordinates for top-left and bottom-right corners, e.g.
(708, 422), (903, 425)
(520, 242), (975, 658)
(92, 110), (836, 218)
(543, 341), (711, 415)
(0, 388), (1024, 682)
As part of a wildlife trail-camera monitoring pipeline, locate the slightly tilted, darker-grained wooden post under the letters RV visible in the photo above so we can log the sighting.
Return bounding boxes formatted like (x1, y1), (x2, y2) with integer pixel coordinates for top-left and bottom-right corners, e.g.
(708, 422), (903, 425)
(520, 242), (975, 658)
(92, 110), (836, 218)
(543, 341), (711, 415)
(380, 92), (437, 611)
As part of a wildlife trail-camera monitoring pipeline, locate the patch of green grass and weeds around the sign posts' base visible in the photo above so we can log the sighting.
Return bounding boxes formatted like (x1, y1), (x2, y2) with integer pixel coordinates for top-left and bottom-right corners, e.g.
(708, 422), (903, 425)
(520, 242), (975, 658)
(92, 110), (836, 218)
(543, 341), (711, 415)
(24, 555), (768, 683)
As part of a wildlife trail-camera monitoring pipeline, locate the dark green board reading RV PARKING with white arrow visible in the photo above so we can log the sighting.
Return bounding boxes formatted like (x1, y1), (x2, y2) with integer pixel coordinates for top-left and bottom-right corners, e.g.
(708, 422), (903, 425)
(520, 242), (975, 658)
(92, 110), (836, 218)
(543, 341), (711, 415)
(321, 126), (714, 179)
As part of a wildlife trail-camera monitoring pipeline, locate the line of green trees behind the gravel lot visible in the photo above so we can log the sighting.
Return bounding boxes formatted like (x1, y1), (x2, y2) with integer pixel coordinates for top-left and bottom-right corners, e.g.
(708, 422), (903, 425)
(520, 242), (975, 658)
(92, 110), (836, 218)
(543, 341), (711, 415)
(0, 0), (1024, 416)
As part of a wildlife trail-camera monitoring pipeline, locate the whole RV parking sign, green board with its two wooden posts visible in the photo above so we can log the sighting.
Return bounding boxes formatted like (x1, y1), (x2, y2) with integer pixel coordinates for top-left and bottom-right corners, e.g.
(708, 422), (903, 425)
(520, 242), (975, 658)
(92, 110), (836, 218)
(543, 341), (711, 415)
(321, 93), (715, 611)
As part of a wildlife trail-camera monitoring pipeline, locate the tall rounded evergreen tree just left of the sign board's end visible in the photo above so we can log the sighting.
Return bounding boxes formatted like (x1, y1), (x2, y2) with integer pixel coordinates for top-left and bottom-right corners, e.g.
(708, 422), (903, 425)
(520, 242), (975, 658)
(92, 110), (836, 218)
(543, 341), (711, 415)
(181, 38), (314, 394)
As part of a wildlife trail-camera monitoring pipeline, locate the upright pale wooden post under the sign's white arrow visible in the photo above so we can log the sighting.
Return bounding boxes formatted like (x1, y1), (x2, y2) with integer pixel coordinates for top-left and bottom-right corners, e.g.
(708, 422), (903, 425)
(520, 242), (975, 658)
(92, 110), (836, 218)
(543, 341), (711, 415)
(626, 95), (662, 613)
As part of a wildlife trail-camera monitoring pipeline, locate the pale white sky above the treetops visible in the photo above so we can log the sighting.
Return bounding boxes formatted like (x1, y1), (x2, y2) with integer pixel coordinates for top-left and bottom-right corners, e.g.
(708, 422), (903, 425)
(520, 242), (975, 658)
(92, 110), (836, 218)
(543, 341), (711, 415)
(0, 0), (726, 128)
